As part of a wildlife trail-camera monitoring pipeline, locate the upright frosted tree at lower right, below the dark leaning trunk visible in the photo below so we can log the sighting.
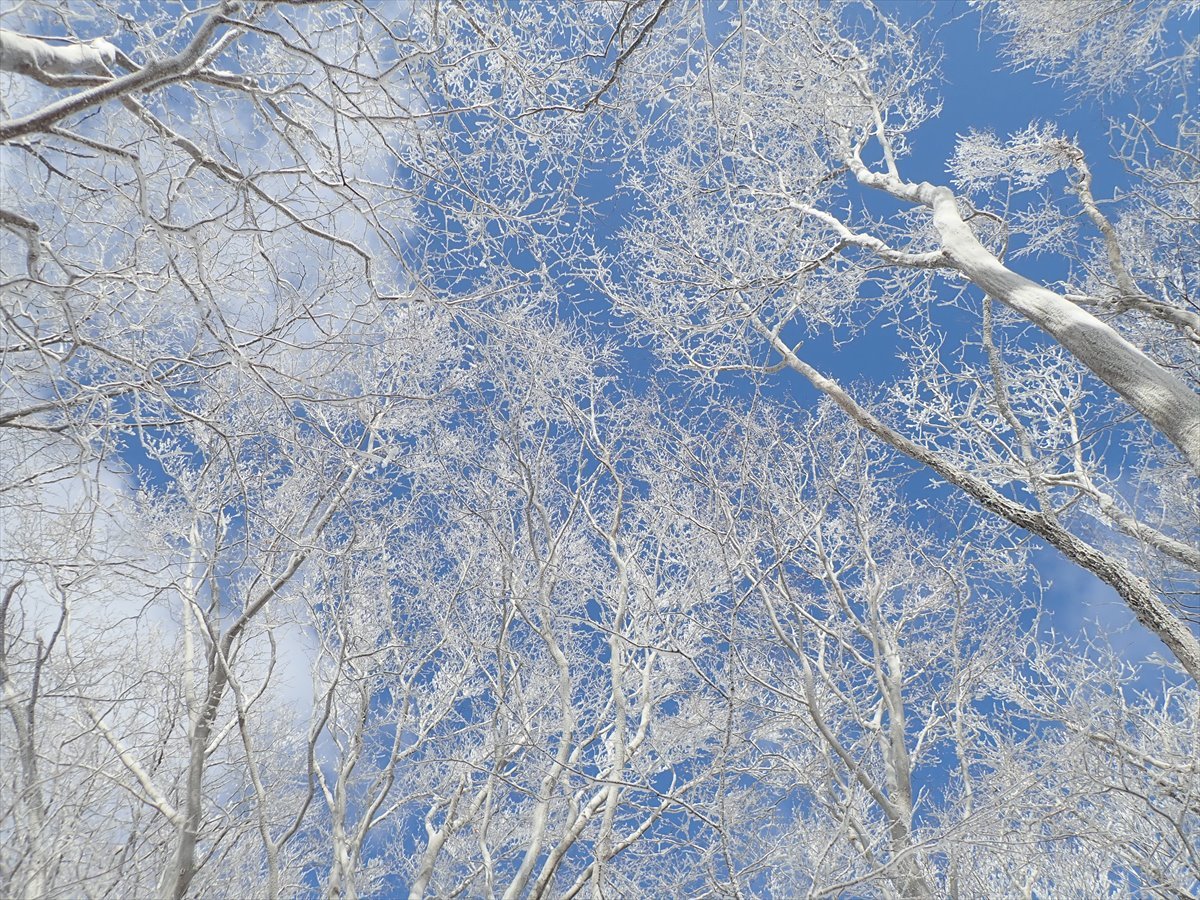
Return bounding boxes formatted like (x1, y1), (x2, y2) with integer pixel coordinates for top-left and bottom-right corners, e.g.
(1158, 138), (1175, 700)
(633, 402), (1200, 896)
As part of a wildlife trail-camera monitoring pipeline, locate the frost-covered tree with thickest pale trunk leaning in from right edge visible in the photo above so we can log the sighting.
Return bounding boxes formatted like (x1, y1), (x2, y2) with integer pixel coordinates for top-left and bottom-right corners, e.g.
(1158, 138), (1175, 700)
(612, 2), (1200, 677)
